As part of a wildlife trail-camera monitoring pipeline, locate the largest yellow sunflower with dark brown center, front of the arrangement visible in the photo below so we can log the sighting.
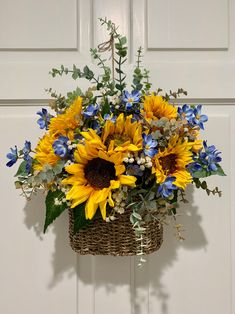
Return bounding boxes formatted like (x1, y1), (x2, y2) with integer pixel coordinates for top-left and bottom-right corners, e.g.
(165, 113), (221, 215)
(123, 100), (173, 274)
(62, 141), (136, 219)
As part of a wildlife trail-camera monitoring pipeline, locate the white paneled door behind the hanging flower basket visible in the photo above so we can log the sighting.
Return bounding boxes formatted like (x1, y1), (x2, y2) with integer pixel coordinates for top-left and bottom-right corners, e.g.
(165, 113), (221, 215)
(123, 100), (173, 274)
(0, 0), (235, 314)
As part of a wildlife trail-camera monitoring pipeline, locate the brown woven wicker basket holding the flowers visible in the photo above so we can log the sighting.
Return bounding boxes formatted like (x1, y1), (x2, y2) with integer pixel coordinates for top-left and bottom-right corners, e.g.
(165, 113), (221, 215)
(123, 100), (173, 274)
(69, 210), (163, 256)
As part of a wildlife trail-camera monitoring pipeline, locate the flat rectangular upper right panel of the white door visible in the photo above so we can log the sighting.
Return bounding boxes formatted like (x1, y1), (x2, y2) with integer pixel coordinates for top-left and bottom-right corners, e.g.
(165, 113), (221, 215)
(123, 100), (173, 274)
(147, 0), (229, 50)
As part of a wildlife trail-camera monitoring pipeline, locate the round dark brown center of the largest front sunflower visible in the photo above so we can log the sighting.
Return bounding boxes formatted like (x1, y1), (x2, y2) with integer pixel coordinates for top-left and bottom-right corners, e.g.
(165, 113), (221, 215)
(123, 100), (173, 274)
(84, 158), (116, 189)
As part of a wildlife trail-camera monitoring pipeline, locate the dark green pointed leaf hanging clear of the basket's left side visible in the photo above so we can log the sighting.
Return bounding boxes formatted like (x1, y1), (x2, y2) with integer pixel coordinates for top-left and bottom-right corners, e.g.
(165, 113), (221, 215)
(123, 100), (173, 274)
(43, 190), (68, 233)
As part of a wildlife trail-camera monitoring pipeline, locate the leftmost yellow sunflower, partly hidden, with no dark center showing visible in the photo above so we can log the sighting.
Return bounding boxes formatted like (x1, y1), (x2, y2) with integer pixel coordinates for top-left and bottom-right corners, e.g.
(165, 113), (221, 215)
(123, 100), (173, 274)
(34, 133), (59, 171)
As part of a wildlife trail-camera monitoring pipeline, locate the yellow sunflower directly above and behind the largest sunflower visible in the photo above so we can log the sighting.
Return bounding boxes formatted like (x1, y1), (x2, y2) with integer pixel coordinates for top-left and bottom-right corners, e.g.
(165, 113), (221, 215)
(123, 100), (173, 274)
(101, 113), (142, 152)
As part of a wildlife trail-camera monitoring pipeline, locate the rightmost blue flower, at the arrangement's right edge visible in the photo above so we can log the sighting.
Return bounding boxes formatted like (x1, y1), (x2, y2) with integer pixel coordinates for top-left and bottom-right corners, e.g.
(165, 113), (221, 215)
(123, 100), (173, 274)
(199, 141), (222, 171)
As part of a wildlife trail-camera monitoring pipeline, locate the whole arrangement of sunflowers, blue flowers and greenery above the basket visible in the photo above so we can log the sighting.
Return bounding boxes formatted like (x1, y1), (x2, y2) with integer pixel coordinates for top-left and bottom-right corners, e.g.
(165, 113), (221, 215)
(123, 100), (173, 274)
(7, 19), (225, 260)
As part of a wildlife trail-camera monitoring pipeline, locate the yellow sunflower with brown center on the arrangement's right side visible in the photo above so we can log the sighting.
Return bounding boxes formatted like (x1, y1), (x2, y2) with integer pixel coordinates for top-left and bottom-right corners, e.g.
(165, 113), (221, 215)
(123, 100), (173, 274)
(152, 136), (193, 189)
